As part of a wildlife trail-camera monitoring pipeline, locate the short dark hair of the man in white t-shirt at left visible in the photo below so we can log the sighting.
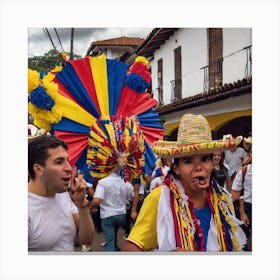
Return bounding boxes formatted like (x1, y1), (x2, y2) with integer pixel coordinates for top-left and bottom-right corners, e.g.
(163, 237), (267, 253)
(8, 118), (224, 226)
(28, 135), (68, 179)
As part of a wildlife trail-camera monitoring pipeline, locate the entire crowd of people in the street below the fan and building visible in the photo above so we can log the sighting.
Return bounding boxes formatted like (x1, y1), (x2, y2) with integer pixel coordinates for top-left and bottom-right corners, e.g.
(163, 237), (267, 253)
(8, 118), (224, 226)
(28, 114), (252, 252)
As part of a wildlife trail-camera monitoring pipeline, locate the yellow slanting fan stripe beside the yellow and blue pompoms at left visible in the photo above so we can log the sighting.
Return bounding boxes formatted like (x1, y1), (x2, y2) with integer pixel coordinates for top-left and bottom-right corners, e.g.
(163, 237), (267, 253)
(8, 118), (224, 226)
(55, 95), (95, 127)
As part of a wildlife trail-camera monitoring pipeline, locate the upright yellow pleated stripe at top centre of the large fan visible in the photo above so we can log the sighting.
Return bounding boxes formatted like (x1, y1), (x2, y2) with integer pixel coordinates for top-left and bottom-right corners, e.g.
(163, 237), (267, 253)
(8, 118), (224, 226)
(89, 54), (109, 117)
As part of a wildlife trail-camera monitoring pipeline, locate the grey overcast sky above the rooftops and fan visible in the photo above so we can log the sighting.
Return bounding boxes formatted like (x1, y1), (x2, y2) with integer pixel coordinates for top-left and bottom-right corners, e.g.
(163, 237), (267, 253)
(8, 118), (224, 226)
(28, 28), (152, 57)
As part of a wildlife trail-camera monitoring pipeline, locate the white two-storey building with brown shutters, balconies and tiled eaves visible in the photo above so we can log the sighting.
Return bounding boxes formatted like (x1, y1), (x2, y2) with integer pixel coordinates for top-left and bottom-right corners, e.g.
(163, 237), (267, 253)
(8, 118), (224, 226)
(138, 28), (252, 138)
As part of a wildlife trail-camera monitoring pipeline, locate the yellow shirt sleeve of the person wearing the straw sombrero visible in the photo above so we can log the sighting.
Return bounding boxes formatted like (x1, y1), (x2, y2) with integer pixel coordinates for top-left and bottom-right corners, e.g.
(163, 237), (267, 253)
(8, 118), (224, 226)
(128, 187), (162, 251)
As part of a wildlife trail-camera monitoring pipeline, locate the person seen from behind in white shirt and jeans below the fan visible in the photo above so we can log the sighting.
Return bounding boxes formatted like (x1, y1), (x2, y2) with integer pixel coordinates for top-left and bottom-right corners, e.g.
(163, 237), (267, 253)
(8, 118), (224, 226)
(90, 172), (134, 251)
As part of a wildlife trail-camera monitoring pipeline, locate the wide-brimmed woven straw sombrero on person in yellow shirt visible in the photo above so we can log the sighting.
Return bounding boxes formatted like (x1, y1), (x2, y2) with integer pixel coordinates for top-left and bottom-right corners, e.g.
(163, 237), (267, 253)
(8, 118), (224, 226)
(152, 114), (243, 158)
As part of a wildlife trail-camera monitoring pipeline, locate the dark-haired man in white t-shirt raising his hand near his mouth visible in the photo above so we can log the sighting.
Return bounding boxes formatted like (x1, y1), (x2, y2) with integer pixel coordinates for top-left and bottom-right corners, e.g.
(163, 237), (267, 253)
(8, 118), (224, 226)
(28, 135), (94, 252)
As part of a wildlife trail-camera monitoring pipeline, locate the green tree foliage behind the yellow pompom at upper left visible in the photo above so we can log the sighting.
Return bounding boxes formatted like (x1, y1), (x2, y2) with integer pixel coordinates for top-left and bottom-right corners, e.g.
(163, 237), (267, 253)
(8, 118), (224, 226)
(28, 49), (81, 74)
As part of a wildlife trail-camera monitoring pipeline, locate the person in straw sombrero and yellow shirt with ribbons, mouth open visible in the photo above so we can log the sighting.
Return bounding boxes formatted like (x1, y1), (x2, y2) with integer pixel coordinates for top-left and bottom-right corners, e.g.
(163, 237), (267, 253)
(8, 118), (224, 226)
(124, 114), (246, 252)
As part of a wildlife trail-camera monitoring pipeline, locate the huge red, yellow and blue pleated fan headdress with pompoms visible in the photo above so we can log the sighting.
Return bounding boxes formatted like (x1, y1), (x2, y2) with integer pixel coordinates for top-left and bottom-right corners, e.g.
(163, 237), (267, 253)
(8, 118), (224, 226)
(29, 55), (164, 183)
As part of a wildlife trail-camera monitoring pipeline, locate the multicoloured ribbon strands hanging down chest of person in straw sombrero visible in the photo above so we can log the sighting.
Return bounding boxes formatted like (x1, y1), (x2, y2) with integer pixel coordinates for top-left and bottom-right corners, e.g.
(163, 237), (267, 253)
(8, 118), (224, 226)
(165, 175), (241, 251)
